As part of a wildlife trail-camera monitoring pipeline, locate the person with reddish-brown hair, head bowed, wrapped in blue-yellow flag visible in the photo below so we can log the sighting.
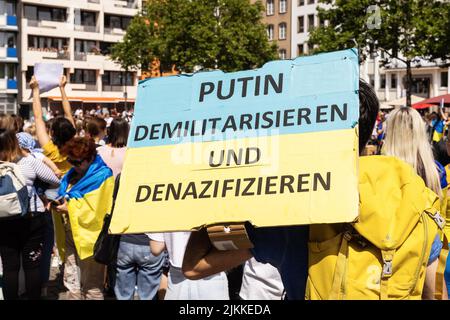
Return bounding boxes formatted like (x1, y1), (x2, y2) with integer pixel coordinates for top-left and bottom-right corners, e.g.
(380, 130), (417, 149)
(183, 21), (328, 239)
(55, 137), (114, 300)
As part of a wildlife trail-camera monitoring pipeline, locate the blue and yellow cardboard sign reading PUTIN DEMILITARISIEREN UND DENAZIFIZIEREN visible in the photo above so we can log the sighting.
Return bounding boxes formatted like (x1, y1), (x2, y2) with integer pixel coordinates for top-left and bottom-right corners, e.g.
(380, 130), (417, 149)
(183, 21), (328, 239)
(110, 49), (359, 233)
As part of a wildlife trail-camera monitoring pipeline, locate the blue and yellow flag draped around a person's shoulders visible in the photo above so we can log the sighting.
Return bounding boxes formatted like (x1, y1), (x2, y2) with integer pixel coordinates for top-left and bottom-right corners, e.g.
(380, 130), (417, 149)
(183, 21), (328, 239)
(59, 155), (114, 260)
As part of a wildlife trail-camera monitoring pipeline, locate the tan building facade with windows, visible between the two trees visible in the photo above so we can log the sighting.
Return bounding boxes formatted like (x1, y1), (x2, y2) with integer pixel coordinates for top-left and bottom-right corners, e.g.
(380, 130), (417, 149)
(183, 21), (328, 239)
(251, 0), (292, 59)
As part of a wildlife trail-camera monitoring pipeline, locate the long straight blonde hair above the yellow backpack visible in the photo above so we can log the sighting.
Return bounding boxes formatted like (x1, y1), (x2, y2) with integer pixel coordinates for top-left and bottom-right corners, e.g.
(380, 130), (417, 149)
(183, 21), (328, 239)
(384, 107), (442, 196)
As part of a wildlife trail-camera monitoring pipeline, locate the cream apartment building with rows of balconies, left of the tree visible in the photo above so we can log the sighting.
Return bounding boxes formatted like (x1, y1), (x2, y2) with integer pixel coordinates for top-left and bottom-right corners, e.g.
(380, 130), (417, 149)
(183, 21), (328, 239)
(17, 0), (142, 115)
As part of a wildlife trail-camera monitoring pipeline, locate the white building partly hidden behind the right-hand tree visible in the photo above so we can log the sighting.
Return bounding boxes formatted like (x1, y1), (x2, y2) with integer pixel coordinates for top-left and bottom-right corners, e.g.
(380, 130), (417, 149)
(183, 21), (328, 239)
(288, 0), (450, 101)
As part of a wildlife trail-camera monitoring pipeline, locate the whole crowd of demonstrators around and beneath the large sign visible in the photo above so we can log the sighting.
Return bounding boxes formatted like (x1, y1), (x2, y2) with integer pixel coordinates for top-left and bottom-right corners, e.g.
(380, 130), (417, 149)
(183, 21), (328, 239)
(0, 76), (450, 300)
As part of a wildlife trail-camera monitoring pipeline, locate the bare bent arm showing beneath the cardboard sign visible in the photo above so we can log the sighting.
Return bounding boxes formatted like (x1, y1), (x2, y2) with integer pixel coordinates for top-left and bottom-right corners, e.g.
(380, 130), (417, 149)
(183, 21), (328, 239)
(182, 228), (252, 280)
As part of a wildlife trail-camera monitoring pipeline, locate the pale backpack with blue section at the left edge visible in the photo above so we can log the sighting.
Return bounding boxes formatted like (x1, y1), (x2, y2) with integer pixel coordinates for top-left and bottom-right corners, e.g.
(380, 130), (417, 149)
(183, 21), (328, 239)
(0, 161), (29, 219)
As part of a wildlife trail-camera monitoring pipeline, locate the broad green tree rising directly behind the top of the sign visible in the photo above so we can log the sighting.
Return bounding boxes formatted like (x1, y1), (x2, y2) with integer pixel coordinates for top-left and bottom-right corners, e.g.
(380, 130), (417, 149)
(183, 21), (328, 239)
(113, 0), (277, 72)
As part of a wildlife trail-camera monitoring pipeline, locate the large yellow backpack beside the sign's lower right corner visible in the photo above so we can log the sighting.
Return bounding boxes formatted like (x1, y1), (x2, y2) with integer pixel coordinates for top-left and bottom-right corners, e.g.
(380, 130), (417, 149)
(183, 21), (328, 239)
(306, 156), (445, 300)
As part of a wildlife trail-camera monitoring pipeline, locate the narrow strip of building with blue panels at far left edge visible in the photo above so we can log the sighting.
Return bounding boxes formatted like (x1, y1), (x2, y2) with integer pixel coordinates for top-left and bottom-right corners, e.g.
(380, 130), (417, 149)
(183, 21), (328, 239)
(0, 0), (19, 113)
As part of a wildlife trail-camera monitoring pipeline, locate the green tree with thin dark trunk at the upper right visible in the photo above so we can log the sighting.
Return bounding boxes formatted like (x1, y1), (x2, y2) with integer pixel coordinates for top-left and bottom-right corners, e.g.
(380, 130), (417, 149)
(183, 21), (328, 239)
(309, 0), (450, 106)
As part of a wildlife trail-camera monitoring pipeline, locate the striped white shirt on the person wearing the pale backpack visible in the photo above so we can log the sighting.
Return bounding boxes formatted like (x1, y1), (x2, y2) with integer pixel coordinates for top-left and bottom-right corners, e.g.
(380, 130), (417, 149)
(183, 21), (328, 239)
(17, 155), (59, 212)
